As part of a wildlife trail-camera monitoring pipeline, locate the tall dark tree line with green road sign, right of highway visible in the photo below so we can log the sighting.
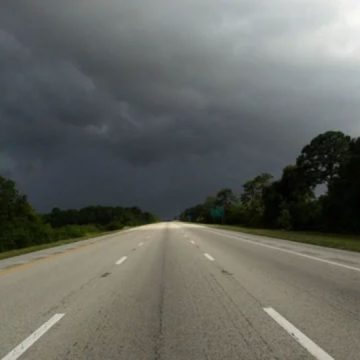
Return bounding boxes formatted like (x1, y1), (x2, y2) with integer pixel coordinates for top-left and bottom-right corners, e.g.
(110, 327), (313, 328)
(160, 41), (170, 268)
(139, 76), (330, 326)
(180, 131), (360, 233)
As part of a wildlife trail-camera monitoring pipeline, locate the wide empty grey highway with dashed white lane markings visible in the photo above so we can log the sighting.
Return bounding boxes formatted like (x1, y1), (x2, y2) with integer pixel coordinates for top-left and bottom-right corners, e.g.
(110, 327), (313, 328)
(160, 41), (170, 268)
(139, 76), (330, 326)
(0, 222), (360, 360)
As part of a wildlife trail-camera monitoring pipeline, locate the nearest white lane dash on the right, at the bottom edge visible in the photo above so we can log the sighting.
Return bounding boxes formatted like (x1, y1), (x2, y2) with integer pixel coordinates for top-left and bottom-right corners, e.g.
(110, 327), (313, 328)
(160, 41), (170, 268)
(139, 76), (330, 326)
(264, 307), (334, 360)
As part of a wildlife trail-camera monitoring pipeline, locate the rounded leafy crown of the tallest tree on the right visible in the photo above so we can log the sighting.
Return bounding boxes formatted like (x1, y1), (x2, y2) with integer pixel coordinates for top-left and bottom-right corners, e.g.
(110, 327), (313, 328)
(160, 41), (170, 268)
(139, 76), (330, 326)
(296, 131), (351, 188)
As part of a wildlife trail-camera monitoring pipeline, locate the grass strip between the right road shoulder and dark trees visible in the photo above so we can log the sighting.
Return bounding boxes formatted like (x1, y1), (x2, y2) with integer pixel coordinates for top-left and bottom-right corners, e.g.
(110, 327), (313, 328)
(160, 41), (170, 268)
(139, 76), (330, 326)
(207, 225), (360, 252)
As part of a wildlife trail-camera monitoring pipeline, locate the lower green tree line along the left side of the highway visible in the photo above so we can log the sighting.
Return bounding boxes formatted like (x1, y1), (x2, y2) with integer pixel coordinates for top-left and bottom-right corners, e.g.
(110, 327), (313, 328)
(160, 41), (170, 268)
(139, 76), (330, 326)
(0, 176), (157, 252)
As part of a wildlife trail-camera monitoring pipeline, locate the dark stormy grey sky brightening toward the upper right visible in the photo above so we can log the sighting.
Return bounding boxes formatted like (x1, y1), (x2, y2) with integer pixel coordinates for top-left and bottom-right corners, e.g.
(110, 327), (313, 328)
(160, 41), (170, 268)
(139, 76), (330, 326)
(0, 0), (360, 218)
